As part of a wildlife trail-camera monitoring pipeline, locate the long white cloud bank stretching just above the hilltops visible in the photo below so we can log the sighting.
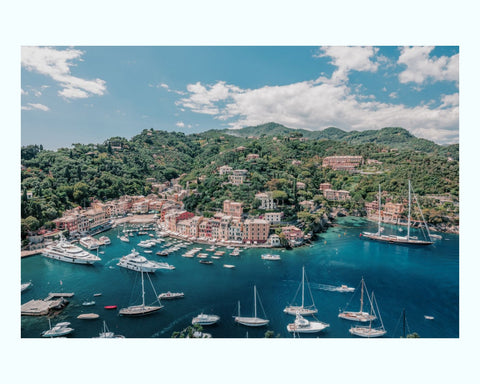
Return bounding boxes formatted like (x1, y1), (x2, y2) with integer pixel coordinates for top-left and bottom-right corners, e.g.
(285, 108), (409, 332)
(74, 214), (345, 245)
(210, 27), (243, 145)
(177, 76), (459, 143)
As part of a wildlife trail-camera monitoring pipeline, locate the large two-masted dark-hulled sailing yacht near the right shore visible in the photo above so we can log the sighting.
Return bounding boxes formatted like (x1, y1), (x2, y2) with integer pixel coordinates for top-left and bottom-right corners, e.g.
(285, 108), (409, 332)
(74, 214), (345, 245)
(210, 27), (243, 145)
(360, 180), (433, 245)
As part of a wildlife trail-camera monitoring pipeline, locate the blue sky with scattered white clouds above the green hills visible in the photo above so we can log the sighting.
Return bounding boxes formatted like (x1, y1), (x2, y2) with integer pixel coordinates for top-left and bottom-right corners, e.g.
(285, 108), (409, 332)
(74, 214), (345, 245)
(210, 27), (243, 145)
(21, 45), (459, 149)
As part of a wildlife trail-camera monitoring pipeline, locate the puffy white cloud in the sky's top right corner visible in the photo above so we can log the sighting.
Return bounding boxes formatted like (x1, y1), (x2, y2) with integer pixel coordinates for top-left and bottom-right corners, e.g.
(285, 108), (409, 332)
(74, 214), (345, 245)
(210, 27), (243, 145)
(398, 47), (459, 84)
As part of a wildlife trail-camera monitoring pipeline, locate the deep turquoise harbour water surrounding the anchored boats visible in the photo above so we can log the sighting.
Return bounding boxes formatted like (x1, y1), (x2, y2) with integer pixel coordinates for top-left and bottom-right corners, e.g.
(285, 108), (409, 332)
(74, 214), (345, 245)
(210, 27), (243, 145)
(21, 217), (459, 338)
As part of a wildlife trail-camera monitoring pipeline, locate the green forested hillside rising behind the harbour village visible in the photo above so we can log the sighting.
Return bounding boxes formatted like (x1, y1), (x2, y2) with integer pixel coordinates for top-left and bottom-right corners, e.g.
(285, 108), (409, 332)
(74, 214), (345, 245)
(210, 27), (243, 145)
(21, 123), (459, 234)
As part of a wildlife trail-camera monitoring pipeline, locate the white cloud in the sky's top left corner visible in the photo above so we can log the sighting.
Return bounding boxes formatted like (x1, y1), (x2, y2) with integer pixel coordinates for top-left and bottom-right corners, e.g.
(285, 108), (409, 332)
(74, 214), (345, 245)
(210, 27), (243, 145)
(22, 47), (107, 99)
